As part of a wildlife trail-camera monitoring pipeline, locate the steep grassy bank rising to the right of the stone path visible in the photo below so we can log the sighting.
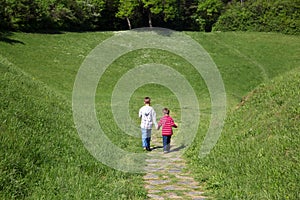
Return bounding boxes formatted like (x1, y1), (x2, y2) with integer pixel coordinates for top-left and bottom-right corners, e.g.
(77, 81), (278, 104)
(186, 68), (300, 199)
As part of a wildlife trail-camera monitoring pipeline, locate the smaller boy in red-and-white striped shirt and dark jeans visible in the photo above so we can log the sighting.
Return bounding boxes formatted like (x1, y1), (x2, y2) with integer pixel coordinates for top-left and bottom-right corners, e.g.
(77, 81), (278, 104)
(157, 108), (177, 153)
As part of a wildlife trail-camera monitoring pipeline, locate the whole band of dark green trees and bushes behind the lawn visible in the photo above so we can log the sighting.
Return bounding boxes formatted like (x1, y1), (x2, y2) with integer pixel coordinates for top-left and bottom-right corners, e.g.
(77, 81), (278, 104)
(0, 0), (300, 34)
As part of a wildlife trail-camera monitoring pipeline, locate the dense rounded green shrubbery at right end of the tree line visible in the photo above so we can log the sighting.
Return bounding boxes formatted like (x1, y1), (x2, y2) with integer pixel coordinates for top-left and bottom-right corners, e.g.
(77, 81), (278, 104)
(214, 0), (300, 34)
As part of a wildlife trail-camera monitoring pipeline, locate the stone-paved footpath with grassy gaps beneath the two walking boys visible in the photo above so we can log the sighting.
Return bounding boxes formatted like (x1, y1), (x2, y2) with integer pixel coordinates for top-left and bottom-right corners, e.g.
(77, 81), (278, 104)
(144, 133), (207, 200)
